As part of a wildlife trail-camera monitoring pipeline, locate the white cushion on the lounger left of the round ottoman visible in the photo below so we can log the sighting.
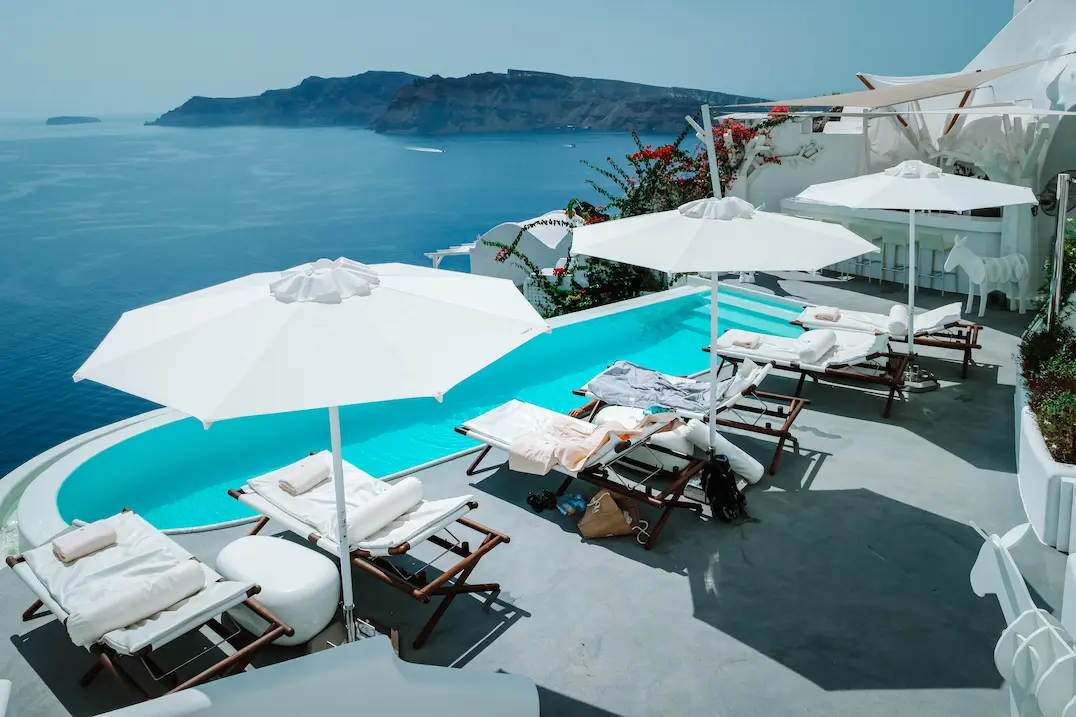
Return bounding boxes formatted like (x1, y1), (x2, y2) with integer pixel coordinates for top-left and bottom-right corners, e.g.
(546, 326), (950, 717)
(23, 512), (254, 655)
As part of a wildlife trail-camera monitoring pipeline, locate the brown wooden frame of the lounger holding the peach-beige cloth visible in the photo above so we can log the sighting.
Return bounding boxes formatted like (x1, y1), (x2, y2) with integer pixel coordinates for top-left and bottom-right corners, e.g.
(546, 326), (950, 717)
(455, 426), (707, 550)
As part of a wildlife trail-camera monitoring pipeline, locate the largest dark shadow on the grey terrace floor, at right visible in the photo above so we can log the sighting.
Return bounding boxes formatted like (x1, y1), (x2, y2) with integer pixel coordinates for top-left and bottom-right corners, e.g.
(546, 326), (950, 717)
(609, 489), (1005, 691)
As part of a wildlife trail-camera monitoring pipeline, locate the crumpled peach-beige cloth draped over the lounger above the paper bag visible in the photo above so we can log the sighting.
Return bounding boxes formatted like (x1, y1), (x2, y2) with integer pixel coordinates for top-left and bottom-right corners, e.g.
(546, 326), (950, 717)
(508, 411), (677, 476)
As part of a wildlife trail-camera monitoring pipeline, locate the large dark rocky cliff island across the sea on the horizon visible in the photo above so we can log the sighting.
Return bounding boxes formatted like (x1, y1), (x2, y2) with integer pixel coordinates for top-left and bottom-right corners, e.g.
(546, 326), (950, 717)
(146, 70), (761, 135)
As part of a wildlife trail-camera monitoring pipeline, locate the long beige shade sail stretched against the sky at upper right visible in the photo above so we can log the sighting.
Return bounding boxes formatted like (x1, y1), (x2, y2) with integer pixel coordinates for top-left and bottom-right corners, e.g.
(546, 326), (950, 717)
(731, 55), (1060, 109)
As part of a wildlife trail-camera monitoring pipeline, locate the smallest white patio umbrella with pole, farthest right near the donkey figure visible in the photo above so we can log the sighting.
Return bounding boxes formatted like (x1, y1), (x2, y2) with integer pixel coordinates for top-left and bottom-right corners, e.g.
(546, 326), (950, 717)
(796, 159), (1038, 344)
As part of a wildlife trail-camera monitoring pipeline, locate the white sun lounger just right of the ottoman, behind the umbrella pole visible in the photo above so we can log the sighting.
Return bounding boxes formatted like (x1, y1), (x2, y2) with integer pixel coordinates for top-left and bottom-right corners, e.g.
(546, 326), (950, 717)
(228, 451), (509, 649)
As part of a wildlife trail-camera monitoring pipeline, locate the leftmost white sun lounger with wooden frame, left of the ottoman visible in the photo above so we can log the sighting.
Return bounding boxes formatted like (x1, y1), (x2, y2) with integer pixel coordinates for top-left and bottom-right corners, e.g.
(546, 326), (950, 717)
(8, 511), (292, 698)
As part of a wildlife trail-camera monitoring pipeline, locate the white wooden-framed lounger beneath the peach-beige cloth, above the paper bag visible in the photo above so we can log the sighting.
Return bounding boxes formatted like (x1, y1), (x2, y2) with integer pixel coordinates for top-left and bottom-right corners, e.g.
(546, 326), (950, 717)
(456, 398), (706, 550)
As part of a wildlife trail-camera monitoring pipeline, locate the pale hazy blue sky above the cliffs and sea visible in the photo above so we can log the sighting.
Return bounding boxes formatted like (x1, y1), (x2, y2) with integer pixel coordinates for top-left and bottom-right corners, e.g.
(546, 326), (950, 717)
(0, 0), (1013, 117)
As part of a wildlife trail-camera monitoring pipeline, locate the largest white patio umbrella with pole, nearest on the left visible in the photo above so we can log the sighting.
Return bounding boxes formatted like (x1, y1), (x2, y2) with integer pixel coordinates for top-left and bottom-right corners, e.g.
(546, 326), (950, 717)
(74, 258), (549, 639)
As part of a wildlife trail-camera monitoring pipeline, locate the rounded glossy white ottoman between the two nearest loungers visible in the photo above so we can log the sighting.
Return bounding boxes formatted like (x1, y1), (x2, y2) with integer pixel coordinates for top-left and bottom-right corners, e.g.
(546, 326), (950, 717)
(216, 535), (340, 645)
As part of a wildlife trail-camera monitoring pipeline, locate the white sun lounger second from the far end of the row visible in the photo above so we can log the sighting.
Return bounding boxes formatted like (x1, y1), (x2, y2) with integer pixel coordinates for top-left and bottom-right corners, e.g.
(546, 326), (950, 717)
(703, 331), (910, 418)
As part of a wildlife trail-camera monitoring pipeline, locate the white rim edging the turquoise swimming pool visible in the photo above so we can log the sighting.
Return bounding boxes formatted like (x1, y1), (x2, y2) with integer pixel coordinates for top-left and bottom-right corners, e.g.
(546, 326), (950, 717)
(8, 277), (804, 546)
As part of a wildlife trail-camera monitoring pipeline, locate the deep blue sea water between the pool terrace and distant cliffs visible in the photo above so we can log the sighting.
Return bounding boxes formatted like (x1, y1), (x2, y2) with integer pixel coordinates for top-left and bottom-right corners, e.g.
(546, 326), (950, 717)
(0, 118), (665, 476)
